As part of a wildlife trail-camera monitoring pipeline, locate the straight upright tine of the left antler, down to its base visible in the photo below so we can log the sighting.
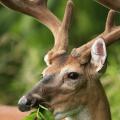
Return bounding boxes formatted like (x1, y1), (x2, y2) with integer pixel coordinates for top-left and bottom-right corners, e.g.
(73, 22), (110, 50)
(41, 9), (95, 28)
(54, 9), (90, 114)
(54, 0), (73, 50)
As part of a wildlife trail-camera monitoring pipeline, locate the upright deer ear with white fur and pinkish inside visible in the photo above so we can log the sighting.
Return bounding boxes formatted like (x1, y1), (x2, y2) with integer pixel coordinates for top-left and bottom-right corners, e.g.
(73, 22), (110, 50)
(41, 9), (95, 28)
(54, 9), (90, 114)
(91, 38), (107, 72)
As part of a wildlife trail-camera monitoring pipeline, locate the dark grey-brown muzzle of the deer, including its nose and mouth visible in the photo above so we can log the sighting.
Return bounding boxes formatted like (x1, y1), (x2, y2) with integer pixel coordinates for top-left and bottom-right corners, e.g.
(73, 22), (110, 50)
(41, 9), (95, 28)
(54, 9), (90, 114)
(18, 76), (52, 112)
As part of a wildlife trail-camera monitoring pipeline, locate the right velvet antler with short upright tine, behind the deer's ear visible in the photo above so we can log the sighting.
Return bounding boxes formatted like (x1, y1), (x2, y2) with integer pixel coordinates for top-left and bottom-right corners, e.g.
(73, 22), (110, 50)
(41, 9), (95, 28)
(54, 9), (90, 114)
(72, 10), (120, 64)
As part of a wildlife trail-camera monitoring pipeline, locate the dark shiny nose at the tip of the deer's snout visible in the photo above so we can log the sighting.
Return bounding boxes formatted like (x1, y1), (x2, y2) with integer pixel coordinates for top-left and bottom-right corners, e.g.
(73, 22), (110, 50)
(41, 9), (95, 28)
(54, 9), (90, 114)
(18, 96), (36, 112)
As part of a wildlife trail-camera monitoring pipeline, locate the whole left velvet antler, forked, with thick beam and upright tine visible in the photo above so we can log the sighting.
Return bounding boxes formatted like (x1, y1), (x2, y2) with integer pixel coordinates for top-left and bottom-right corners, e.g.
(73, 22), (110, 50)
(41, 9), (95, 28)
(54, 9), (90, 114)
(0, 0), (73, 65)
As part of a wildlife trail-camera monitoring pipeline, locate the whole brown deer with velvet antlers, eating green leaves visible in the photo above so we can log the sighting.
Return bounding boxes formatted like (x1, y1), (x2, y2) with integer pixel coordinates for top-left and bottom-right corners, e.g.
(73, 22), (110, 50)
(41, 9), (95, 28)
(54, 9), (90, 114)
(0, 0), (120, 120)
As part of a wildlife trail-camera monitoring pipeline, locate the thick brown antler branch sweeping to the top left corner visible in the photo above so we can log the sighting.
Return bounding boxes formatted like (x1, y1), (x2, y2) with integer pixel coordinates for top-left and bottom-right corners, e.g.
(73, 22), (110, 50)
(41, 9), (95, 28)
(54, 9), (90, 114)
(0, 0), (61, 38)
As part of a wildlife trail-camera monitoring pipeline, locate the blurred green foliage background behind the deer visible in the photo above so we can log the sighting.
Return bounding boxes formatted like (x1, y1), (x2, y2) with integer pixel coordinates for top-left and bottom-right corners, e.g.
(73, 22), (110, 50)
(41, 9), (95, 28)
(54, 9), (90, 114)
(0, 0), (120, 120)
